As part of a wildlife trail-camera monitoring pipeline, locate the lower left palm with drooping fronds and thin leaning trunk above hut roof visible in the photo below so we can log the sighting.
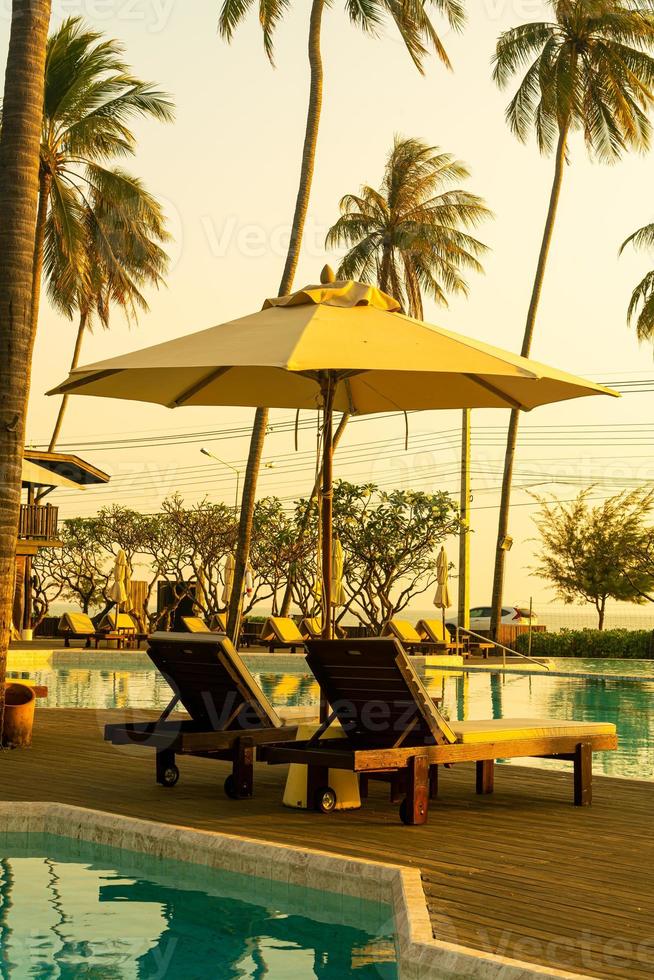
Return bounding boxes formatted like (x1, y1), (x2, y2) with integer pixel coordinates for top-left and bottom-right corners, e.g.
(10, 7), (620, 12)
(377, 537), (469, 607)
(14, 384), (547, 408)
(44, 170), (170, 452)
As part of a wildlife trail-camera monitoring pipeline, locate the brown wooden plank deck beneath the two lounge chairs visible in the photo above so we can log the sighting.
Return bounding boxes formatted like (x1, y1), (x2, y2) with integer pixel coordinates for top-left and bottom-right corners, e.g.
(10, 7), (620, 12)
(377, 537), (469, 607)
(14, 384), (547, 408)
(0, 709), (654, 980)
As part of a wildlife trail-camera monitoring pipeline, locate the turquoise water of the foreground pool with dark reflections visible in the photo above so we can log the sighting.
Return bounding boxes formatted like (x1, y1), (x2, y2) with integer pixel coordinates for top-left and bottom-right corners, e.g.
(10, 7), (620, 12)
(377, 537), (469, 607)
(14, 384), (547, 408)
(0, 834), (397, 980)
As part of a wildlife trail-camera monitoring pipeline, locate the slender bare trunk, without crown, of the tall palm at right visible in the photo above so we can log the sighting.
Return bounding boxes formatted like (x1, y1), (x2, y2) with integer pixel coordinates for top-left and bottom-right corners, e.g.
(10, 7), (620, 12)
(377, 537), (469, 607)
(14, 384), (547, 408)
(491, 123), (569, 637)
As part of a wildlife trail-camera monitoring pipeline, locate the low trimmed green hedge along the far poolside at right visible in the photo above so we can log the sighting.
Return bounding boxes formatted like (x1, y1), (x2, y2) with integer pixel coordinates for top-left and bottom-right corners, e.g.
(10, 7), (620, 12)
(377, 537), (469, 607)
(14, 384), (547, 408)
(515, 630), (654, 660)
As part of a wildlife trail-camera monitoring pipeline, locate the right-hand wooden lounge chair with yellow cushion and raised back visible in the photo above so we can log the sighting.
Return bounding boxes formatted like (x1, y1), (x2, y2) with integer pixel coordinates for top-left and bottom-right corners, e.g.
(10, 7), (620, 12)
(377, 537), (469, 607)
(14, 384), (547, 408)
(263, 639), (617, 824)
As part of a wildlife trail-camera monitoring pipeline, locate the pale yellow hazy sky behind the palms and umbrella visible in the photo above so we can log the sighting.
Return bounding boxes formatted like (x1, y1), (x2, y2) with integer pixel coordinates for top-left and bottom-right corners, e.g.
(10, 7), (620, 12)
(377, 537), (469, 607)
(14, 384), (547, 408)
(5, 0), (654, 605)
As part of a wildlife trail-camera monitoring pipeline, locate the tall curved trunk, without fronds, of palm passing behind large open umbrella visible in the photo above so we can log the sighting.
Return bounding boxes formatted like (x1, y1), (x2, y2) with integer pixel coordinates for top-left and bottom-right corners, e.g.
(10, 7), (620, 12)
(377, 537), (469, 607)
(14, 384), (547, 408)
(227, 0), (325, 643)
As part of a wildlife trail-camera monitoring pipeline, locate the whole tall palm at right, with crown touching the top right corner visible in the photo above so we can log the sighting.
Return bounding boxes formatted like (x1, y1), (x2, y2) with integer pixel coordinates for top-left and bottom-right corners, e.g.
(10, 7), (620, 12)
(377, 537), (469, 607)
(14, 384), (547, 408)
(492, 0), (654, 631)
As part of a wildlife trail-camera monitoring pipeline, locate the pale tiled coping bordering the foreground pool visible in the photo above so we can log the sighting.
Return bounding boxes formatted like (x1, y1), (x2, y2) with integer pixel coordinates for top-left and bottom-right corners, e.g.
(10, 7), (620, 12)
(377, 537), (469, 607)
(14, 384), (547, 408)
(0, 802), (589, 980)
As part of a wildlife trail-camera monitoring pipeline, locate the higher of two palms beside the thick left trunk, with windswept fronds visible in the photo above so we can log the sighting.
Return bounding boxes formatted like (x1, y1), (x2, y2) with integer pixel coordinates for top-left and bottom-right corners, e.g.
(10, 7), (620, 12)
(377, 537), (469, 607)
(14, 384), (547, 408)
(32, 17), (173, 344)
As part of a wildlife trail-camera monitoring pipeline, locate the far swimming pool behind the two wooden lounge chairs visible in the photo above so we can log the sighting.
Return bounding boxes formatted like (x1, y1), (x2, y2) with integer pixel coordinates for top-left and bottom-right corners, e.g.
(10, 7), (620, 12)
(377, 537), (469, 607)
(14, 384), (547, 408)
(9, 651), (654, 781)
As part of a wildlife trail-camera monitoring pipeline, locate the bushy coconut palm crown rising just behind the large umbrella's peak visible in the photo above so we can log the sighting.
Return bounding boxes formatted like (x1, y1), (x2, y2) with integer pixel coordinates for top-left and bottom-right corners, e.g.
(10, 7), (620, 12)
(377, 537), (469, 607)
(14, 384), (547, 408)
(326, 137), (490, 319)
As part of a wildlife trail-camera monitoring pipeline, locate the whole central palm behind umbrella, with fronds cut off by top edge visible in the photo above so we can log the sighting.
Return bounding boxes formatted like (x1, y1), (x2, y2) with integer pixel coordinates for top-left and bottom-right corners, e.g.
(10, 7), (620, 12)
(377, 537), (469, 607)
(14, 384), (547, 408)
(219, 0), (464, 637)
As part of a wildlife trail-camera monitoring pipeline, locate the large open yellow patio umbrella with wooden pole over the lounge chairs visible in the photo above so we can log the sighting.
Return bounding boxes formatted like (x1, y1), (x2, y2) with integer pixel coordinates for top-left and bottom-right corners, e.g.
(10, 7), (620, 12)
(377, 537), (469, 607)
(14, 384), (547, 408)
(50, 270), (614, 636)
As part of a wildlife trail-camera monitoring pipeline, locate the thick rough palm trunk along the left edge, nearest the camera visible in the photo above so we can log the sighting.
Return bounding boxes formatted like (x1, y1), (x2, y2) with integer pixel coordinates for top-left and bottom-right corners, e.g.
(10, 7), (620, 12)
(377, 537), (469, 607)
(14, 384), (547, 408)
(0, 0), (50, 731)
